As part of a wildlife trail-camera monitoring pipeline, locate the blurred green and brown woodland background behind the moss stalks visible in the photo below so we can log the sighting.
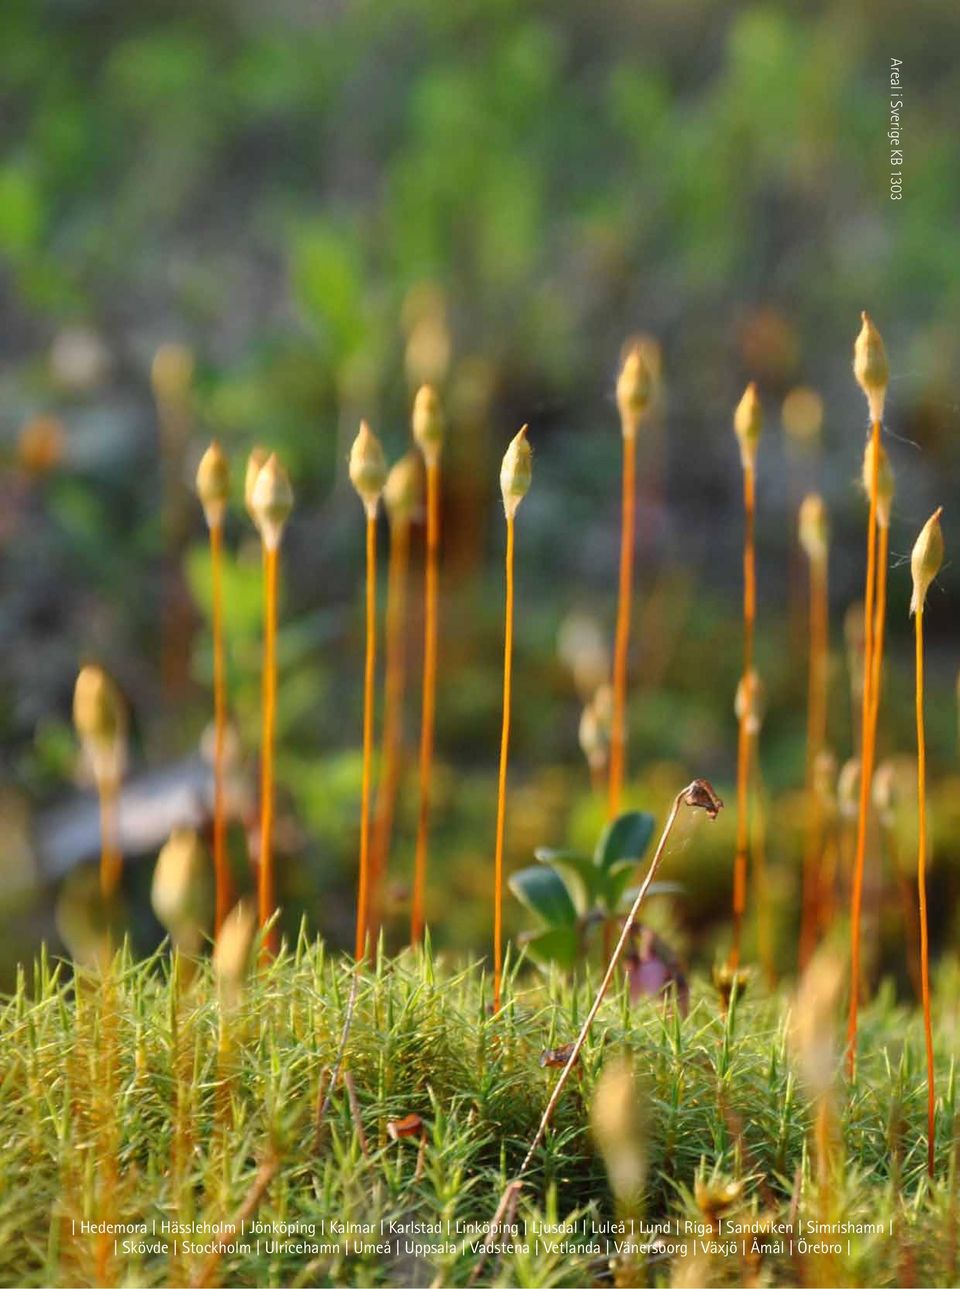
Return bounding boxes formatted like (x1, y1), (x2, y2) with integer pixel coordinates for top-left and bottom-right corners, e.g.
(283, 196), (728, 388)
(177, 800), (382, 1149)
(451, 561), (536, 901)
(0, 0), (960, 980)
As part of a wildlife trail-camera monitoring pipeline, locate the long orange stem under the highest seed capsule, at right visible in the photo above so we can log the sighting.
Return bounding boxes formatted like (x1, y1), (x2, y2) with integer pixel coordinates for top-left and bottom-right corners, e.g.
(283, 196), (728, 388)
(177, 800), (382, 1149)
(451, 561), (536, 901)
(847, 420), (880, 1078)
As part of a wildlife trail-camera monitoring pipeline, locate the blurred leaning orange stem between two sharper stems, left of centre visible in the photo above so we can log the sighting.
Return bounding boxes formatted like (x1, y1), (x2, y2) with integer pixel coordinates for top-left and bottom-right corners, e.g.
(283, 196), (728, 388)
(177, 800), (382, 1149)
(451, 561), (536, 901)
(370, 518), (410, 933)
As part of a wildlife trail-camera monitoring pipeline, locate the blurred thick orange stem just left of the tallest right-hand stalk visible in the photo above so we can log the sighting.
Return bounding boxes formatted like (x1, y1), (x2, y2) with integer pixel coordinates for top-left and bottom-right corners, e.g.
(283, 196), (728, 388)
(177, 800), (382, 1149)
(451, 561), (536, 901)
(800, 559), (830, 971)
